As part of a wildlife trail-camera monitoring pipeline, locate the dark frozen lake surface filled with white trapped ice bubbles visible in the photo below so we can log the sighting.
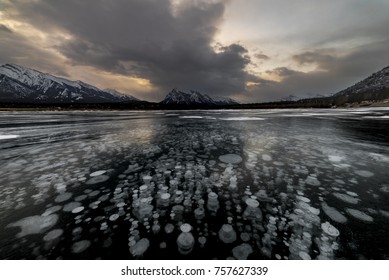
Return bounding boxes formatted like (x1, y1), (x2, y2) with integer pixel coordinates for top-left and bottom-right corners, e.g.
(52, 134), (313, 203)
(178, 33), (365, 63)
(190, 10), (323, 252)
(0, 108), (389, 259)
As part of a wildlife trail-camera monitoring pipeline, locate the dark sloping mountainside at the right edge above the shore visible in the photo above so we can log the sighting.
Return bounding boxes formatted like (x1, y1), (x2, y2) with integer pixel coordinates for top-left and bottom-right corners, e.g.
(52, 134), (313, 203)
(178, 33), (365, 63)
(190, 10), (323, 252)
(332, 66), (389, 104)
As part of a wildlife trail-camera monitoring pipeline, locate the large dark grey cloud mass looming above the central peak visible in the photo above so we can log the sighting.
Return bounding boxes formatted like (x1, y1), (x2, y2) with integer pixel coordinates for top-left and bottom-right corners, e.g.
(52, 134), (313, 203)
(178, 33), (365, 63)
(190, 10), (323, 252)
(5, 0), (253, 98)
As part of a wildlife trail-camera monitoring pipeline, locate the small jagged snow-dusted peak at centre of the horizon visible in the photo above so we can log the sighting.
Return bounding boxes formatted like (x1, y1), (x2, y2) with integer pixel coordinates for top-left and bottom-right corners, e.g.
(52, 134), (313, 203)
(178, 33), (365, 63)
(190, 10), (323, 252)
(160, 88), (239, 107)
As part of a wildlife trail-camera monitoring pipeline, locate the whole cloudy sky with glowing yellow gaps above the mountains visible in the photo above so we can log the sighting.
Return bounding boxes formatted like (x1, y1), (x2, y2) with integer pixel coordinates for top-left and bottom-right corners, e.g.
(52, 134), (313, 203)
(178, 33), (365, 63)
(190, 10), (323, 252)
(0, 0), (389, 102)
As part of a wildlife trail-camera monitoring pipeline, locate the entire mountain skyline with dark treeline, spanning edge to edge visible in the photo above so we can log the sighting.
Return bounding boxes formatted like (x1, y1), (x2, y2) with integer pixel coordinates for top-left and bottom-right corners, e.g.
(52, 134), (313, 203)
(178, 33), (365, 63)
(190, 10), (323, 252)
(0, 64), (389, 109)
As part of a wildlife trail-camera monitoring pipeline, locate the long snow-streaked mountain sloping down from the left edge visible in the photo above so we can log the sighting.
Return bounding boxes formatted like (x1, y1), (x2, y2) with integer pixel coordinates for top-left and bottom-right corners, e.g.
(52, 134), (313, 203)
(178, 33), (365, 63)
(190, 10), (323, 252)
(0, 64), (139, 104)
